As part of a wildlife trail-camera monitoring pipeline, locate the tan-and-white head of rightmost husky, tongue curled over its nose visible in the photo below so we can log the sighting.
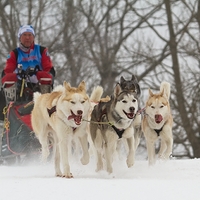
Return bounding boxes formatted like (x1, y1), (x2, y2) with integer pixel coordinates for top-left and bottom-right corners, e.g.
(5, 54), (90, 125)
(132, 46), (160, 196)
(146, 82), (170, 124)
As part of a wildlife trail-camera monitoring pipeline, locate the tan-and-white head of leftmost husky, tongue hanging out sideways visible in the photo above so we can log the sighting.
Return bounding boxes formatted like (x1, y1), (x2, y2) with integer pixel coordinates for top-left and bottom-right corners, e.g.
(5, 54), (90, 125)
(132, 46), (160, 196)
(57, 81), (90, 127)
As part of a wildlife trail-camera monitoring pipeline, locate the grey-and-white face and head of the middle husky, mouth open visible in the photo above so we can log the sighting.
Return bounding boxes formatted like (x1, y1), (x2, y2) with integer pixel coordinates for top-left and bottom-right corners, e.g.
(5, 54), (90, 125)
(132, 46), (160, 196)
(112, 84), (138, 120)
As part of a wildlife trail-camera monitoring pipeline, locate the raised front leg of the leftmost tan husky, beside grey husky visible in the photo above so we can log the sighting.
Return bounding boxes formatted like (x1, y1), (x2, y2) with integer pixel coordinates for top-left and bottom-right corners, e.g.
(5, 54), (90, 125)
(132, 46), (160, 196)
(79, 134), (89, 165)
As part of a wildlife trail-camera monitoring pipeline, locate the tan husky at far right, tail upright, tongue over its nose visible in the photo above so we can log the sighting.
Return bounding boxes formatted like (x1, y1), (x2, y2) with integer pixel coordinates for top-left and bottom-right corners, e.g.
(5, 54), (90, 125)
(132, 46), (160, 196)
(142, 82), (173, 165)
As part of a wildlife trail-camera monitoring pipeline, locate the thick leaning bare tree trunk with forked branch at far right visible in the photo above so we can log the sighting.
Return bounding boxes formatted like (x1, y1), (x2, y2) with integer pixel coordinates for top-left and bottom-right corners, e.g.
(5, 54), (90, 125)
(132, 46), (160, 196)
(164, 0), (200, 157)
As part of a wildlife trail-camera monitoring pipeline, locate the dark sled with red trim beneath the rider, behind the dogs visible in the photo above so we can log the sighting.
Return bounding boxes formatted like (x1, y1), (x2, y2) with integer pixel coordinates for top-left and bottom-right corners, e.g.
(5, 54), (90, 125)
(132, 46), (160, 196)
(0, 69), (49, 165)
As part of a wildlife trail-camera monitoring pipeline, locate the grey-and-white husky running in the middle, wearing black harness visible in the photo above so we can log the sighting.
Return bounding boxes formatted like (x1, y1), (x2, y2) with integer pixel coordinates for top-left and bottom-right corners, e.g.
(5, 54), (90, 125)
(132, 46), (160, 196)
(90, 83), (138, 174)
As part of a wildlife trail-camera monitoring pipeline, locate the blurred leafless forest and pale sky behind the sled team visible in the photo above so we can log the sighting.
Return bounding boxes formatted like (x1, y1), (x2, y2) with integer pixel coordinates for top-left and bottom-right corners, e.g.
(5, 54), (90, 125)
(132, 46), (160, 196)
(0, 0), (200, 158)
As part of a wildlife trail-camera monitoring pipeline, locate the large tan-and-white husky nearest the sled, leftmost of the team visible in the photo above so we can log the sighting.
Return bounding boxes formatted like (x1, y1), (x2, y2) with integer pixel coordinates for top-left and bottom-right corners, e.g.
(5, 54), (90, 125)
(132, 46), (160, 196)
(31, 81), (101, 178)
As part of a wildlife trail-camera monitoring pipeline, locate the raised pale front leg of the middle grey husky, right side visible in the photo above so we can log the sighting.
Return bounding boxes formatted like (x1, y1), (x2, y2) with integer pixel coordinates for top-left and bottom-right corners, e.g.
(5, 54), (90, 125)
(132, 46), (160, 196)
(126, 137), (135, 167)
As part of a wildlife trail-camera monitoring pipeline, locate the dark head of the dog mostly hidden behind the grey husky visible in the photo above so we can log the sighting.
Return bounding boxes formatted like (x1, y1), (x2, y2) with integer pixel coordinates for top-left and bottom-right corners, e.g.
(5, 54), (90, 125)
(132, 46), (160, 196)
(119, 75), (141, 97)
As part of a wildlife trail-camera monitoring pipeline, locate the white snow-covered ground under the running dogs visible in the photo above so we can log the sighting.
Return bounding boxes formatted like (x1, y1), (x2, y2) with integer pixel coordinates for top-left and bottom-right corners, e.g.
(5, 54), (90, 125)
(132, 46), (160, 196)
(0, 157), (200, 200)
